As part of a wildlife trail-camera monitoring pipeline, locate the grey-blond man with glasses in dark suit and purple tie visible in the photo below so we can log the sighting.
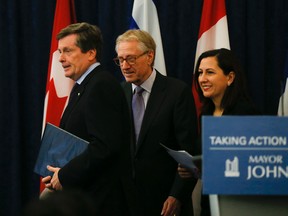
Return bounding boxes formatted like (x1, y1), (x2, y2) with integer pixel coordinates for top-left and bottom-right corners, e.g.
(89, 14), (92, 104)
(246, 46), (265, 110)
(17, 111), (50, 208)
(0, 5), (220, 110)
(114, 30), (197, 216)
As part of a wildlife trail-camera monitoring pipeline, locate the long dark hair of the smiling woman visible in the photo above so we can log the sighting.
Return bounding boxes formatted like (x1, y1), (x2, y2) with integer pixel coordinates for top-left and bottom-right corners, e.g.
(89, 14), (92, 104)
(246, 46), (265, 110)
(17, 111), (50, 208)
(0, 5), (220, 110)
(194, 48), (250, 113)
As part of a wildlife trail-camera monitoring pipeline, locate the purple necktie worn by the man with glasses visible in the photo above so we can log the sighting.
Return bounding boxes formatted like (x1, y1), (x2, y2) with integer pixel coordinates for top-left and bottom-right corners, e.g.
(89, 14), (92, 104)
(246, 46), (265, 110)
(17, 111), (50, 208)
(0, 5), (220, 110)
(132, 86), (145, 144)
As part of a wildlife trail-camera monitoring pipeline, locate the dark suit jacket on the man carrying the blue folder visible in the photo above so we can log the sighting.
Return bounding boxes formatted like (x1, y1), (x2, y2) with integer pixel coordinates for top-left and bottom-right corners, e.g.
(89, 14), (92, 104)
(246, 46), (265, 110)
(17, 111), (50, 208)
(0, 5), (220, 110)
(59, 66), (131, 216)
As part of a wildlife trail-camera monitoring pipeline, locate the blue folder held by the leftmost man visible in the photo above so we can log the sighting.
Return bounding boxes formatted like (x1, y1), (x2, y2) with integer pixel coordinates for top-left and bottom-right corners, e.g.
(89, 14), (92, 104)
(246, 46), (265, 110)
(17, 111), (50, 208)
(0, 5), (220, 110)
(34, 123), (89, 177)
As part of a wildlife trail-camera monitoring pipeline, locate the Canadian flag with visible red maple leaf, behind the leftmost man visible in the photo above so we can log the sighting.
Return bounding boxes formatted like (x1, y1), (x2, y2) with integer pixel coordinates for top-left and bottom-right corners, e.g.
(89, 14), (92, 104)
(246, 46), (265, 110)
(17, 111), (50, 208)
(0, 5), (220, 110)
(40, 0), (76, 191)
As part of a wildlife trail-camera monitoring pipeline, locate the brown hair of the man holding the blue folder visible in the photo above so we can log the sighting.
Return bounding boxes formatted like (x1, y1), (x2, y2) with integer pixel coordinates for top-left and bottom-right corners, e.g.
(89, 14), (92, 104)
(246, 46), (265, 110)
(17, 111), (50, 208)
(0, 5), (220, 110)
(57, 22), (103, 61)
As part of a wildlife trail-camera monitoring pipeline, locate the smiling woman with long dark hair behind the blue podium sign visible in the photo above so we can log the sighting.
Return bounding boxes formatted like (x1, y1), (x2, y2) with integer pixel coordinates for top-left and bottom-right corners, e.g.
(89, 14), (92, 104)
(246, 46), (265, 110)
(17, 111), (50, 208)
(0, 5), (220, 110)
(178, 48), (260, 216)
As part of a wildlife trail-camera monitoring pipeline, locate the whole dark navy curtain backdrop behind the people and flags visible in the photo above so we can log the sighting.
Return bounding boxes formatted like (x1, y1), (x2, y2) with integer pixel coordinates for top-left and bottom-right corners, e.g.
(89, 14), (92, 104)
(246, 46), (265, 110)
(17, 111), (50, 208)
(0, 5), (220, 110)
(0, 0), (288, 216)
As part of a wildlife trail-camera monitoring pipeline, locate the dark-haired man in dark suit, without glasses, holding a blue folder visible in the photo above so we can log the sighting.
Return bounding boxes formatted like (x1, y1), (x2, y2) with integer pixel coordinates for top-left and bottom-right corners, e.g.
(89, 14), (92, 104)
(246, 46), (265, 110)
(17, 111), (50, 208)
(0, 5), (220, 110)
(43, 23), (131, 216)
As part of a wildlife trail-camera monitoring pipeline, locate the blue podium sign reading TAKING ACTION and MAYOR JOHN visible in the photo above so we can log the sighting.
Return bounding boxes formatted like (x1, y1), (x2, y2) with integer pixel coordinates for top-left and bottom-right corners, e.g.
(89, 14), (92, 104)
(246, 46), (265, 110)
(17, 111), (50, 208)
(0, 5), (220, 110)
(202, 116), (288, 195)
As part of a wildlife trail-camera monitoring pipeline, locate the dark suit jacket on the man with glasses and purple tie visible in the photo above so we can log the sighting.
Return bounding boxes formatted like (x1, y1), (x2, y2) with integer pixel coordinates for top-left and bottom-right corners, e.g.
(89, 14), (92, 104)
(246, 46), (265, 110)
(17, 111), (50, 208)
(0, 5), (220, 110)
(123, 72), (197, 216)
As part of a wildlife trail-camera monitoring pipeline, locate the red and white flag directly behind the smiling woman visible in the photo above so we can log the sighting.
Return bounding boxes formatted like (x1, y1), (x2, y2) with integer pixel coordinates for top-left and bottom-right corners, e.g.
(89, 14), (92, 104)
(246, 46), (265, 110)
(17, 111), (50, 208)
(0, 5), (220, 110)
(192, 0), (230, 116)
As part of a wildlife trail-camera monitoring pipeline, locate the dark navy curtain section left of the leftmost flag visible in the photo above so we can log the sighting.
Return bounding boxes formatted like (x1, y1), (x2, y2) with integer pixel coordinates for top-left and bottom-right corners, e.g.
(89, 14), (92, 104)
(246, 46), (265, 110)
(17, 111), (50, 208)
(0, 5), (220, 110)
(0, 0), (55, 216)
